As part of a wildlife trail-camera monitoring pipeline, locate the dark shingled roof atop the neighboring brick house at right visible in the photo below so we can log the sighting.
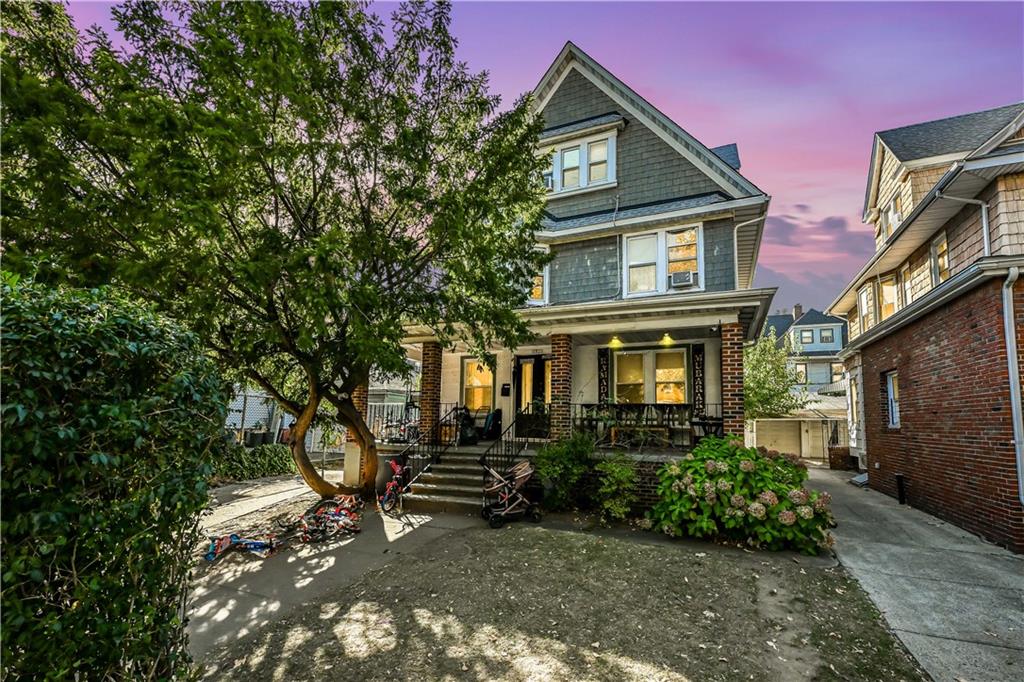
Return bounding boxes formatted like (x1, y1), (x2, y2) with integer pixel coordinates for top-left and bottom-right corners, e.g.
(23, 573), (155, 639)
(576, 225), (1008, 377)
(878, 101), (1024, 162)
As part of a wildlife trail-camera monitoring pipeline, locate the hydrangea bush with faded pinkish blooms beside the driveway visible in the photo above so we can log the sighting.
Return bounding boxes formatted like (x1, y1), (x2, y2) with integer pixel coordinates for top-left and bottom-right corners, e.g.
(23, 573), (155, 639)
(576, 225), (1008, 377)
(649, 438), (833, 554)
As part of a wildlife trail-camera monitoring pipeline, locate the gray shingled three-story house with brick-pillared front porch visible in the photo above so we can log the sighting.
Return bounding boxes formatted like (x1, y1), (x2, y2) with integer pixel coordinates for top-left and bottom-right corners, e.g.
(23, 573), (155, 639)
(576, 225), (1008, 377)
(393, 43), (775, 509)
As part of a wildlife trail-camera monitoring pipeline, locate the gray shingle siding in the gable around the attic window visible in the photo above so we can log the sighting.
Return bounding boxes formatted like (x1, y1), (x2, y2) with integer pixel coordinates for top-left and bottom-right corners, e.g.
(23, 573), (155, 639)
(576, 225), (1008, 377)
(543, 70), (719, 218)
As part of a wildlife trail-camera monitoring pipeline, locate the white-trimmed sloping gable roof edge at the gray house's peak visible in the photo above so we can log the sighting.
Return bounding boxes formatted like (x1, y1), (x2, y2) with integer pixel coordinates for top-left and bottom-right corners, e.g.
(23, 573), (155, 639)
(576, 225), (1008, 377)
(534, 42), (764, 199)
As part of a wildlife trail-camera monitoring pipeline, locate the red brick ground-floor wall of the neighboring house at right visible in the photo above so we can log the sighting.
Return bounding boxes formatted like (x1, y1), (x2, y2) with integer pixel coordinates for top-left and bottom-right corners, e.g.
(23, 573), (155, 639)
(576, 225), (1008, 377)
(861, 280), (1024, 552)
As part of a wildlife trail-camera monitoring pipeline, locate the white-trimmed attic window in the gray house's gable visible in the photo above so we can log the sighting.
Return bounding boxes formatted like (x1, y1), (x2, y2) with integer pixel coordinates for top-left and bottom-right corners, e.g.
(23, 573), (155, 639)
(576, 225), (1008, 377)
(542, 131), (615, 195)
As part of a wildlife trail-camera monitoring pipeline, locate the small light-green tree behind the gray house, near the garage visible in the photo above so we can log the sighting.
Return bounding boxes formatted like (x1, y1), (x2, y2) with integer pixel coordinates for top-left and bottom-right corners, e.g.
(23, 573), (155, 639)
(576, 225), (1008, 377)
(743, 328), (808, 419)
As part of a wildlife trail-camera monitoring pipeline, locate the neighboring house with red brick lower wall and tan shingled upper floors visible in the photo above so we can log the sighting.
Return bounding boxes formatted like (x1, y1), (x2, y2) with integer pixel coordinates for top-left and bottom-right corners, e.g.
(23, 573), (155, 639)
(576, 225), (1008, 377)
(829, 102), (1024, 552)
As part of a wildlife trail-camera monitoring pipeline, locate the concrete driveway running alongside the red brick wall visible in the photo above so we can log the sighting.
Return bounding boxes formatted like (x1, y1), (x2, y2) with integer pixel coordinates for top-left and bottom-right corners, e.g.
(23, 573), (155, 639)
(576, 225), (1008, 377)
(810, 469), (1024, 682)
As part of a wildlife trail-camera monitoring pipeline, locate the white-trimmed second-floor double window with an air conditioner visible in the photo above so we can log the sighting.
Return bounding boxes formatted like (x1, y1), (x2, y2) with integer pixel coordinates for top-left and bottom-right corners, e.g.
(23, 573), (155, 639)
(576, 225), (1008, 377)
(623, 224), (703, 297)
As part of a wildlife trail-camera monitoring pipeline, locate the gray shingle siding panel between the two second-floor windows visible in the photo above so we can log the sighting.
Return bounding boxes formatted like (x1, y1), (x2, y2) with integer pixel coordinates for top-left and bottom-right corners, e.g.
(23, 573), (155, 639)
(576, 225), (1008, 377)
(548, 237), (622, 305)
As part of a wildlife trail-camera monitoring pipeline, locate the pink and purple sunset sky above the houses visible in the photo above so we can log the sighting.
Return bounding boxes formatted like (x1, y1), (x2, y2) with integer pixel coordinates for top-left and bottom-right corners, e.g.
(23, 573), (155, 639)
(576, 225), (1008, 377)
(72, 2), (1024, 309)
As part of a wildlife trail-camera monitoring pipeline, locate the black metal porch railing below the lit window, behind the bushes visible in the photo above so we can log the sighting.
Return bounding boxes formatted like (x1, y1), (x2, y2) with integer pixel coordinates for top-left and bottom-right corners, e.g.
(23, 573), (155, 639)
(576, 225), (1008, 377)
(569, 402), (724, 450)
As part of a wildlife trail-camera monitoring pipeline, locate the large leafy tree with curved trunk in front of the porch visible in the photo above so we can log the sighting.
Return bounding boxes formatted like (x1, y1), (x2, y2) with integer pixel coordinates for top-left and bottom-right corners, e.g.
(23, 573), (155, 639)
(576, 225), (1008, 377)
(2, 2), (543, 495)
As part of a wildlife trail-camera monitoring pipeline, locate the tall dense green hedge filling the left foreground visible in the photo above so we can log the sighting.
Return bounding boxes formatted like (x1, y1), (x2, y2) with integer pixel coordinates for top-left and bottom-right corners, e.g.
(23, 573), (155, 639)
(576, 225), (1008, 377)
(0, 275), (228, 679)
